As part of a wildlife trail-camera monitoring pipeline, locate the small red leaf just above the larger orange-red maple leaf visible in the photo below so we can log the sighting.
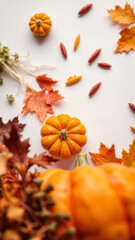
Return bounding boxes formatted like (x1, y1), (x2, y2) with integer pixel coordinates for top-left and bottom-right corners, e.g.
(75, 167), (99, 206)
(36, 74), (58, 91)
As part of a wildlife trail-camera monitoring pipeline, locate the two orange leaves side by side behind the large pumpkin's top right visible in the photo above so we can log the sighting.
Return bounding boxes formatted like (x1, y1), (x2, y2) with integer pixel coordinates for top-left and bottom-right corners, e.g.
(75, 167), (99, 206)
(89, 139), (135, 167)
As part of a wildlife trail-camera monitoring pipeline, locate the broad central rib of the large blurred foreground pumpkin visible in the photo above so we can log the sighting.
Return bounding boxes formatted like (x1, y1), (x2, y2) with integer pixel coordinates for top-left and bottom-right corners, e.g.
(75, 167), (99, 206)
(71, 166), (129, 240)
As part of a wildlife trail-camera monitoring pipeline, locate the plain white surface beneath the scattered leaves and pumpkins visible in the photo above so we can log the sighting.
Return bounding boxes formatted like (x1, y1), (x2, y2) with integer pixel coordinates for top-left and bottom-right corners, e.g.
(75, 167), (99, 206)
(0, 0), (135, 168)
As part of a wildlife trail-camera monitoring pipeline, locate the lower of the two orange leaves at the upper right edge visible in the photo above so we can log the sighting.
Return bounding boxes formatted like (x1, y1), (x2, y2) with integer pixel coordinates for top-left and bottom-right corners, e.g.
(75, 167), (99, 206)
(115, 26), (135, 53)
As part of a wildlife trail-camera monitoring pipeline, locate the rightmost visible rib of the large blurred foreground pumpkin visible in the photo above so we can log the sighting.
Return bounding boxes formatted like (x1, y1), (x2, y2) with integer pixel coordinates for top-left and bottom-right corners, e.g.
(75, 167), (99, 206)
(101, 164), (135, 239)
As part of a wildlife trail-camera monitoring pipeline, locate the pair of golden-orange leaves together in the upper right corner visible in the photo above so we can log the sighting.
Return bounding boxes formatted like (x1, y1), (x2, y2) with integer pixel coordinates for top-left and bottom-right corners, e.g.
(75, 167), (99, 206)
(108, 3), (135, 53)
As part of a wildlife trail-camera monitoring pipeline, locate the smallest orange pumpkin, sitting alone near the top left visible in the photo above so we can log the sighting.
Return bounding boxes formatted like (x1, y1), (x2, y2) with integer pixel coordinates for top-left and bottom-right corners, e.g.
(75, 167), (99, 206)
(29, 13), (52, 37)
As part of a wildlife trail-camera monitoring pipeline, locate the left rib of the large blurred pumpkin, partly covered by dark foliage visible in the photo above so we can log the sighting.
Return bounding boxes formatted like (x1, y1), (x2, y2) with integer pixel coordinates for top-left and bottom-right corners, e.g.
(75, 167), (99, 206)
(41, 169), (77, 237)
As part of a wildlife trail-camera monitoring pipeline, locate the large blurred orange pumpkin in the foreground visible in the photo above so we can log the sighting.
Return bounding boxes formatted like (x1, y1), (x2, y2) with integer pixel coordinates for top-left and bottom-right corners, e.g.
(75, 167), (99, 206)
(42, 155), (135, 240)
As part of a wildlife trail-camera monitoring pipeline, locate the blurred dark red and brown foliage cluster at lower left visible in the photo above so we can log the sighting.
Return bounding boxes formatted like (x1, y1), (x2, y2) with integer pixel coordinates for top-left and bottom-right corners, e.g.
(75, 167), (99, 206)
(0, 118), (72, 240)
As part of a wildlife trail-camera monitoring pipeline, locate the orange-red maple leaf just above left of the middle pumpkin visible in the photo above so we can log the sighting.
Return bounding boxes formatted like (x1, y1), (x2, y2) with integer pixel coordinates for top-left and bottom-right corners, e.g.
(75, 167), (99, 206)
(22, 87), (63, 122)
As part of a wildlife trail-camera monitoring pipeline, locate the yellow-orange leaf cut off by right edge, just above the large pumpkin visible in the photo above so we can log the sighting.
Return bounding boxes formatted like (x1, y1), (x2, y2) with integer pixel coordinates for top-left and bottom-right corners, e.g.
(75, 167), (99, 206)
(122, 139), (135, 167)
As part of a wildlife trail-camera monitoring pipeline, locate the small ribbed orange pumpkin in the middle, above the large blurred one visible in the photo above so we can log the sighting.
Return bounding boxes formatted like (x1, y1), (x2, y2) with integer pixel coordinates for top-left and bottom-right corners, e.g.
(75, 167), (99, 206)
(41, 114), (87, 159)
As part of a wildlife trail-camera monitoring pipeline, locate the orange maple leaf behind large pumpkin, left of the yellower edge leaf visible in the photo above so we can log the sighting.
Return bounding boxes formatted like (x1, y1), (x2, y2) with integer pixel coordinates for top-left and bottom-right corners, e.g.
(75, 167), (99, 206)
(89, 143), (122, 165)
